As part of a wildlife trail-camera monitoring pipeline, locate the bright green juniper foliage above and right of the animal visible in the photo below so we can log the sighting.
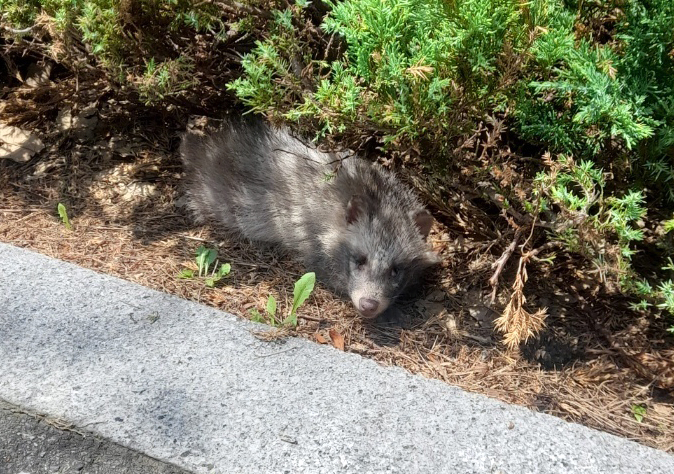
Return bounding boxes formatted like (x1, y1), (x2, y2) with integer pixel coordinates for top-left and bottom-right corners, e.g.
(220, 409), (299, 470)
(229, 0), (674, 326)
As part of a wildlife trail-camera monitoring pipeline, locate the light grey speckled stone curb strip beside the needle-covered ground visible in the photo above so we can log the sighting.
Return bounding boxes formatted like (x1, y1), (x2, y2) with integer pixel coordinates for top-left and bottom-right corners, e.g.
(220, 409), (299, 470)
(0, 244), (674, 474)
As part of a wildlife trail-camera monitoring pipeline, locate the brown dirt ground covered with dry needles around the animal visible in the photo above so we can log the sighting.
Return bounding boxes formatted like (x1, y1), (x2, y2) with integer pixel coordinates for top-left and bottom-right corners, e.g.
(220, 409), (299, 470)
(0, 69), (674, 453)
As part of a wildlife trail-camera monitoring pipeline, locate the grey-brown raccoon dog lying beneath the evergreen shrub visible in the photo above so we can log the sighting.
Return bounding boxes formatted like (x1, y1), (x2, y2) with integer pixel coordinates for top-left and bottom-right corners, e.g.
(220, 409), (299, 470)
(181, 121), (437, 318)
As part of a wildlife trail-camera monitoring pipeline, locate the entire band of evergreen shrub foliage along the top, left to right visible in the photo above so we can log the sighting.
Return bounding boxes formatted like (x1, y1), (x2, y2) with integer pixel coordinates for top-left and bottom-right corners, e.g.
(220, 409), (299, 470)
(0, 0), (674, 330)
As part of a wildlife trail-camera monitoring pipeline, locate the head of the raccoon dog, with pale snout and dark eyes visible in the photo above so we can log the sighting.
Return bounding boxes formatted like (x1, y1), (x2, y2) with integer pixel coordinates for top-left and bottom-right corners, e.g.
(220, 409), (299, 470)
(344, 195), (439, 319)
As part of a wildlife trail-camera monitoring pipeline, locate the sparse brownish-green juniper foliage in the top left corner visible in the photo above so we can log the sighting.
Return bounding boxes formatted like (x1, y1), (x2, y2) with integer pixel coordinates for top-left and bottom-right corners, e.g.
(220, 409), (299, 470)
(0, 0), (274, 104)
